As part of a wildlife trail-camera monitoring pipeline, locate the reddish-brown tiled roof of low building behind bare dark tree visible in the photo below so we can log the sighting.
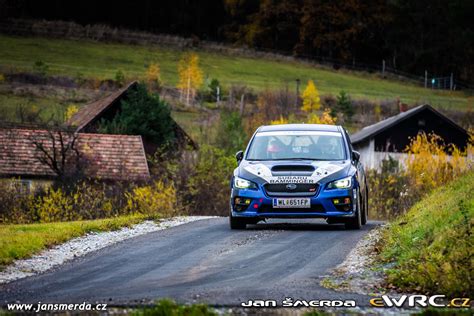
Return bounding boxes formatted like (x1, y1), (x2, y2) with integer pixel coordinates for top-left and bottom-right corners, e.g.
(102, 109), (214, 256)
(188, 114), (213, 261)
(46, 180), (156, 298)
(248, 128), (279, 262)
(0, 128), (150, 181)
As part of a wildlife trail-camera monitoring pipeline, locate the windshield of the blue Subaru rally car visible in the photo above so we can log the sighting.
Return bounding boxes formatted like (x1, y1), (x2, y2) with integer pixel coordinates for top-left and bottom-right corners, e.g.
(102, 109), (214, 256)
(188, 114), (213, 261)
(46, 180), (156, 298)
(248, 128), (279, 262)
(247, 131), (345, 160)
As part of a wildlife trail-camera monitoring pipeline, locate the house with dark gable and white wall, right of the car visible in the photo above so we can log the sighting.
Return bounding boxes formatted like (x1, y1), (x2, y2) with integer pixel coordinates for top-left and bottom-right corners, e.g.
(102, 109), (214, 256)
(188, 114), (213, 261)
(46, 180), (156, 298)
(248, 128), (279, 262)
(351, 104), (469, 169)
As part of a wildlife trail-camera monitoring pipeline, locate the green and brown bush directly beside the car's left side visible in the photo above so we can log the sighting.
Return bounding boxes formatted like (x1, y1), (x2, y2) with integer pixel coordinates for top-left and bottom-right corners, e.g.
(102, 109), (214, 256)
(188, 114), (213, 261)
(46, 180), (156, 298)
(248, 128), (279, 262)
(187, 145), (237, 216)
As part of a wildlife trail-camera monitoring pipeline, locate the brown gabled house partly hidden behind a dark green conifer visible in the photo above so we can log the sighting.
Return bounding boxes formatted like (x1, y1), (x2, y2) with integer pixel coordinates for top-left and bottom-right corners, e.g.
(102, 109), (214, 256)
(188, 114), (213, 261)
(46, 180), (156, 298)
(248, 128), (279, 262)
(68, 81), (198, 154)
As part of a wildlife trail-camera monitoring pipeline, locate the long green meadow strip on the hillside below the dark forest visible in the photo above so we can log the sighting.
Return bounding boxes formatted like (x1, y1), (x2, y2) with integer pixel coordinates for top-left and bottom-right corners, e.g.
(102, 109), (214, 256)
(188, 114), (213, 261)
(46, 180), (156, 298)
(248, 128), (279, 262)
(0, 35), (473, 110)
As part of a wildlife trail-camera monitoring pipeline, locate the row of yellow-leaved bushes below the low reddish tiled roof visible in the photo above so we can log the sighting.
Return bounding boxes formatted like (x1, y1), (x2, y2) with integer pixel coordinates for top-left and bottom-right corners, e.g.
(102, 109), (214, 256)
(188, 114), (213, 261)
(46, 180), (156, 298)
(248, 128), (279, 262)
(0, 181), (178, 224)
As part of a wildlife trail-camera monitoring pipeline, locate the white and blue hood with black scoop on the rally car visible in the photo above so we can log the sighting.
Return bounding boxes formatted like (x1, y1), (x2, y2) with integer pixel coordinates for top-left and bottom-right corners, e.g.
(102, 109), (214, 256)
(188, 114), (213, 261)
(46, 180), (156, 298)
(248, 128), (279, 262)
(234, 160), (355, 184)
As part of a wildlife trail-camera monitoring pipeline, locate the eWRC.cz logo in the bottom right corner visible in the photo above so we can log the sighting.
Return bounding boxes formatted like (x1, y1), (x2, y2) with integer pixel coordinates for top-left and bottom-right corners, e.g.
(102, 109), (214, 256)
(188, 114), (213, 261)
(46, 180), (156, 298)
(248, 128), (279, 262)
(370, 295), (471, 308)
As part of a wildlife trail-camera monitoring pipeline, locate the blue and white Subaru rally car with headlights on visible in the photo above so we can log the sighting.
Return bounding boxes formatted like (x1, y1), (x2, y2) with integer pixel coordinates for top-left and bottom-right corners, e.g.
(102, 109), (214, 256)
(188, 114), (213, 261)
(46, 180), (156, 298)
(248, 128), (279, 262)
(229, 124), (368, 229)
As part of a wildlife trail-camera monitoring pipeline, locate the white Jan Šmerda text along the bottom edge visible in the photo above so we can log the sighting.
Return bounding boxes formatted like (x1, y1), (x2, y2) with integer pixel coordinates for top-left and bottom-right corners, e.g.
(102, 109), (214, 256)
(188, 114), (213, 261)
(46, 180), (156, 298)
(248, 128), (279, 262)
(241, 297), (357, 307)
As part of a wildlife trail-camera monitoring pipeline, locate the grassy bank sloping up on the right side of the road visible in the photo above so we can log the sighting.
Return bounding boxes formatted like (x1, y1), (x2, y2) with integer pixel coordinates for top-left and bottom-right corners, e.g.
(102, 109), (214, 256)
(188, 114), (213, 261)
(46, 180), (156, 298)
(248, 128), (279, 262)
(381, 171), (474, 297)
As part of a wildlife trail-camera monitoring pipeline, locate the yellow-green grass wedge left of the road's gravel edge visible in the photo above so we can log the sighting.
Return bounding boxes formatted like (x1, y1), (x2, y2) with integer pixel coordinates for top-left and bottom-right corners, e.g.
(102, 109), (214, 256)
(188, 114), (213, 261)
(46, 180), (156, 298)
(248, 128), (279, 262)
(0, 215), (153, 269)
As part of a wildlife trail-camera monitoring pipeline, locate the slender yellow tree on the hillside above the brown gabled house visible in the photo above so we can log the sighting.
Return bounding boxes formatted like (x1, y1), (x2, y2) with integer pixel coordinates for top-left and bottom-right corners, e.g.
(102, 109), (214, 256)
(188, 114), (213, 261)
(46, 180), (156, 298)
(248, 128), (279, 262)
(177, 53), (203, 106)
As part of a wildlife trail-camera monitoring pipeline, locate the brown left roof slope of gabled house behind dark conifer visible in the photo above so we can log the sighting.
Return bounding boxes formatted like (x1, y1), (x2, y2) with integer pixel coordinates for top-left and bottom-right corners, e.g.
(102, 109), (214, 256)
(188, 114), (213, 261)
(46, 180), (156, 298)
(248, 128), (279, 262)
(68, 81), (137, 131)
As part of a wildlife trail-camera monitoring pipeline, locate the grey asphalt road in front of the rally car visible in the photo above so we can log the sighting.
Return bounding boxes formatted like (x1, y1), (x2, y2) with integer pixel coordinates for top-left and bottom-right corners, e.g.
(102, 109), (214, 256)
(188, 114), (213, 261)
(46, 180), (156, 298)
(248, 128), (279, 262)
(0, 218), (377, 306)
